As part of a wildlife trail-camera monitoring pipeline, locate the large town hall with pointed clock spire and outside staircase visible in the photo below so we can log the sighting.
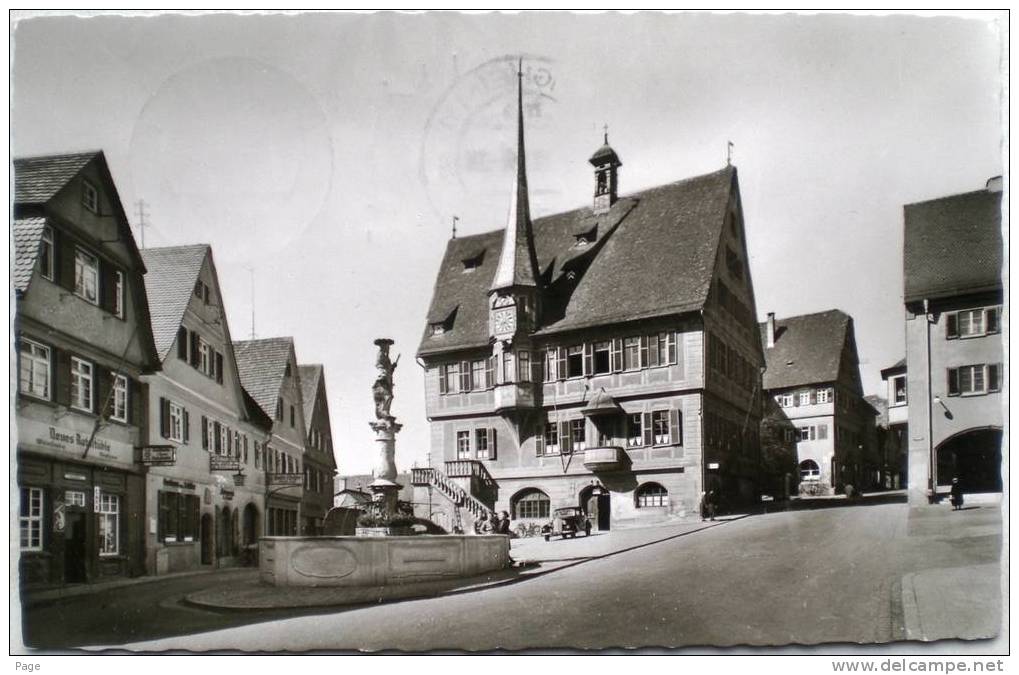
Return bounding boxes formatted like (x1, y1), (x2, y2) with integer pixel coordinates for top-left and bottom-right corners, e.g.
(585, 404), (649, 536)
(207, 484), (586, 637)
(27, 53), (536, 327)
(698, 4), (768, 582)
(413, 68), (763, 529)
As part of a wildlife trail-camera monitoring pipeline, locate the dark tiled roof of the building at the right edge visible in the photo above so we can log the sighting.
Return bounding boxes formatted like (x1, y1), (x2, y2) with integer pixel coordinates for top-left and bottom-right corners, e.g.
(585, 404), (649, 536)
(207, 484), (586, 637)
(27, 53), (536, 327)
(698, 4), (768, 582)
(903, 185), (1002, 302)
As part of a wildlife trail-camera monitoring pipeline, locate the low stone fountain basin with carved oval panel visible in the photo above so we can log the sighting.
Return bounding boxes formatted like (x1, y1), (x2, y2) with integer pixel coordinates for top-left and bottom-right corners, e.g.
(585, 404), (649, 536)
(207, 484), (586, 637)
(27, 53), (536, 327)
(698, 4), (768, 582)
(259, 534), (510, 586)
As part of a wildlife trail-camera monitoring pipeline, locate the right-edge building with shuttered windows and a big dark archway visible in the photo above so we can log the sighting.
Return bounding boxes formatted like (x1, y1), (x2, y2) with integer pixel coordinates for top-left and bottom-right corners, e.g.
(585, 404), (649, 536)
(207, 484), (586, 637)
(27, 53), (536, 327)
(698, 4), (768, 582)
(903, 177), (1006, 505)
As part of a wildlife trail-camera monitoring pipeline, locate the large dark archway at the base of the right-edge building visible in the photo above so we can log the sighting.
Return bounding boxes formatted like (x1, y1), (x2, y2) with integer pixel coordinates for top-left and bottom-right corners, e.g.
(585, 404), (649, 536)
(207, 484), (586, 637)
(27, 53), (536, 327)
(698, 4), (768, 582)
(937, 427), (1002, 492)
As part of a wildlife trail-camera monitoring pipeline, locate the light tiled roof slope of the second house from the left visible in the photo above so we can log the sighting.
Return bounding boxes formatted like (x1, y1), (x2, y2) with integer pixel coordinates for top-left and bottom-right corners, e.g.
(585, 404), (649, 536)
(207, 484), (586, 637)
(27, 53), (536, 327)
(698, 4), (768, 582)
(142, 244), (210, 361)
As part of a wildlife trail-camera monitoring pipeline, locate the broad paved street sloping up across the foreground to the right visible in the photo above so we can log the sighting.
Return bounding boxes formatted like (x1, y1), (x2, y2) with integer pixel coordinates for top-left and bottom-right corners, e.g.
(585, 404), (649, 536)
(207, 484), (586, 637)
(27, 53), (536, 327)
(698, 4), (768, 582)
(19, 504), (1001, 651)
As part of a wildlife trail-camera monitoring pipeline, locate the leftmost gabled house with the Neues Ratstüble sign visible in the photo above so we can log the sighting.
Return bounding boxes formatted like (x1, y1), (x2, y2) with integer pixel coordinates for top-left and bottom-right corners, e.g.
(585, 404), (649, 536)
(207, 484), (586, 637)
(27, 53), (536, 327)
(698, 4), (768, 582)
(11, 152), (159, 585)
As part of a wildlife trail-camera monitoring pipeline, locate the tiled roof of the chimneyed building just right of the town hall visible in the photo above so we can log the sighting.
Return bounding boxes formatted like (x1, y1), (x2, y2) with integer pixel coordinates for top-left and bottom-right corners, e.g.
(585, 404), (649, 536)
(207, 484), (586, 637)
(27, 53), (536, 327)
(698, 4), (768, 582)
(760, 309), (851, 391)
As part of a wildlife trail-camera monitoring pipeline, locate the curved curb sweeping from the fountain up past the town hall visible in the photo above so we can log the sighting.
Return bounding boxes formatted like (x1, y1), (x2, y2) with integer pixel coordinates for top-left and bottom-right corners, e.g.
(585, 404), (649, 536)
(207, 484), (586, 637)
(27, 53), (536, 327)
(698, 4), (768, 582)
(180, 514), (749, 613)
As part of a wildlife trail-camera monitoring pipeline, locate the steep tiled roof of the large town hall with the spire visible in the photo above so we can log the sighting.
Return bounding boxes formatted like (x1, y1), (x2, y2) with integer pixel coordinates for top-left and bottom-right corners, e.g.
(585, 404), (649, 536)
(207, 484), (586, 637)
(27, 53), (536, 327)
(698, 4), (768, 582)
(418, 167), (736, 355)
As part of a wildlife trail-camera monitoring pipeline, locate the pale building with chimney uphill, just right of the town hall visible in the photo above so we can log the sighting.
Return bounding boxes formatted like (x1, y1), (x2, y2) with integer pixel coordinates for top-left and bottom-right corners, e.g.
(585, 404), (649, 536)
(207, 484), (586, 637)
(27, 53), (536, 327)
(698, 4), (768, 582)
(760, 310), (875, 495)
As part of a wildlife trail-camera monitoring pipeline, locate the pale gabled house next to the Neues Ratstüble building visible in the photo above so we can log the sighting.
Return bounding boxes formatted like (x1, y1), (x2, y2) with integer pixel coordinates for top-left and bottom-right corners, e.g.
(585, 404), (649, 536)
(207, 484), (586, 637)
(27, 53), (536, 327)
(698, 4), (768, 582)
(142, 244), (272, 574)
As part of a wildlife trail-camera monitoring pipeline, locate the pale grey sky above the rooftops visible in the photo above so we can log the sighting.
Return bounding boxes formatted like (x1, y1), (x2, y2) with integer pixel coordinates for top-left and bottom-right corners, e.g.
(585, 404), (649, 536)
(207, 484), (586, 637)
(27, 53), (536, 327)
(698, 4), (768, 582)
(11, 12), (1003, 473)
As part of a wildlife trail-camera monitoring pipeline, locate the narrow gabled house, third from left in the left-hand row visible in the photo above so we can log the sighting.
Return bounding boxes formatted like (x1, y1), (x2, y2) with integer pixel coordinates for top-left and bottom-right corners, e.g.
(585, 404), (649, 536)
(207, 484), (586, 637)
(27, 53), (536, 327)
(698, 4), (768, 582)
(233, 338), (308, 536)
